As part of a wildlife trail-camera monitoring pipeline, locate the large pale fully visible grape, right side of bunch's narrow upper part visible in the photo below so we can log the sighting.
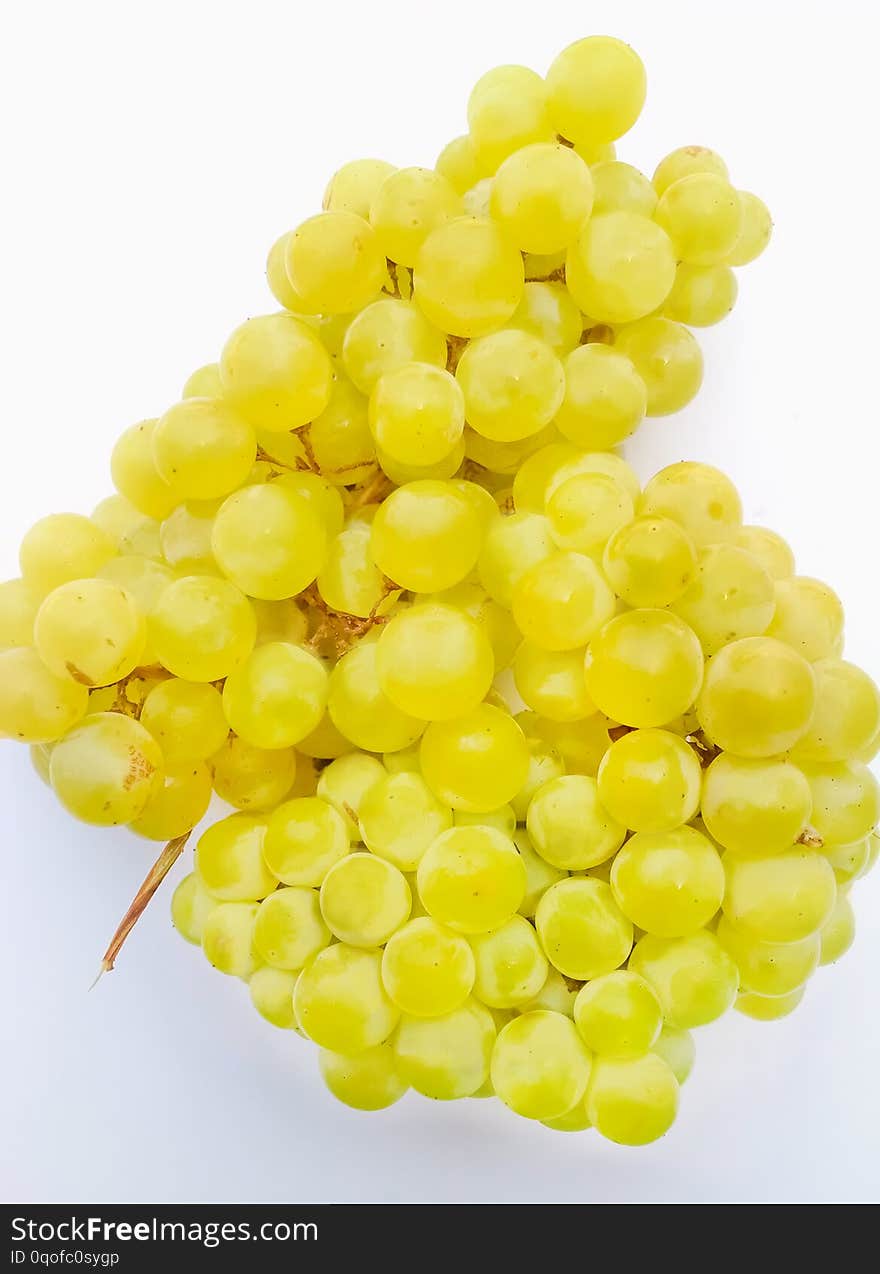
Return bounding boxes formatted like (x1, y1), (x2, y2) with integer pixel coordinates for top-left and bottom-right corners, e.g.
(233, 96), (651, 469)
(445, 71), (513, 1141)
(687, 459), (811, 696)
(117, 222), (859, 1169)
(565, 211), (675, 324)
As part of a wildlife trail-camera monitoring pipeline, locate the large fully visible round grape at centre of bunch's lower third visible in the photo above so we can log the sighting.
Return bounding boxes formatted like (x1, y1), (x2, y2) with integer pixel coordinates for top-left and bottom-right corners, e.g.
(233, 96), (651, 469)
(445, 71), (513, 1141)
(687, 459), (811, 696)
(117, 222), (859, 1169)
(418, 827), (526, 934)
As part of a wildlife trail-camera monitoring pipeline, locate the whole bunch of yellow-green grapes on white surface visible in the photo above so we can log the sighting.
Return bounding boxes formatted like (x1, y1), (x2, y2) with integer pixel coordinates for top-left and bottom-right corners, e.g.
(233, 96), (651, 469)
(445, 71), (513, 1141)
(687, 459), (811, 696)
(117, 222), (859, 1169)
(0, 37), (880, 1144)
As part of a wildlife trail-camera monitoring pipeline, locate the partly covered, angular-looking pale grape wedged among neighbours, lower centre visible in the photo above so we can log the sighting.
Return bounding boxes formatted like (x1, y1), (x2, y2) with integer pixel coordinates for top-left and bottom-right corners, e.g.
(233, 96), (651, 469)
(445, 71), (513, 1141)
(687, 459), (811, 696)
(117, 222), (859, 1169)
(360, 771), (452, 871)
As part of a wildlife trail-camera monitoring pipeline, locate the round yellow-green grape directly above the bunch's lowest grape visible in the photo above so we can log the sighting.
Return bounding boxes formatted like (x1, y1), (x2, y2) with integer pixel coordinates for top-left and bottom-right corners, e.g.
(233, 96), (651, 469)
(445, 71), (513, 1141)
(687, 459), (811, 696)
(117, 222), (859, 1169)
(574, 968), (664, 1057)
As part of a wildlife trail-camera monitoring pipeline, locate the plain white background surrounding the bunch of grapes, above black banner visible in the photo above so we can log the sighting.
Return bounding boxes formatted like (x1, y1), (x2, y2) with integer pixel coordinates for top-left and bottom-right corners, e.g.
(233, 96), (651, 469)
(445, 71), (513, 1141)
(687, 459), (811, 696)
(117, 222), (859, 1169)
(0, 0), (880, 1203)
